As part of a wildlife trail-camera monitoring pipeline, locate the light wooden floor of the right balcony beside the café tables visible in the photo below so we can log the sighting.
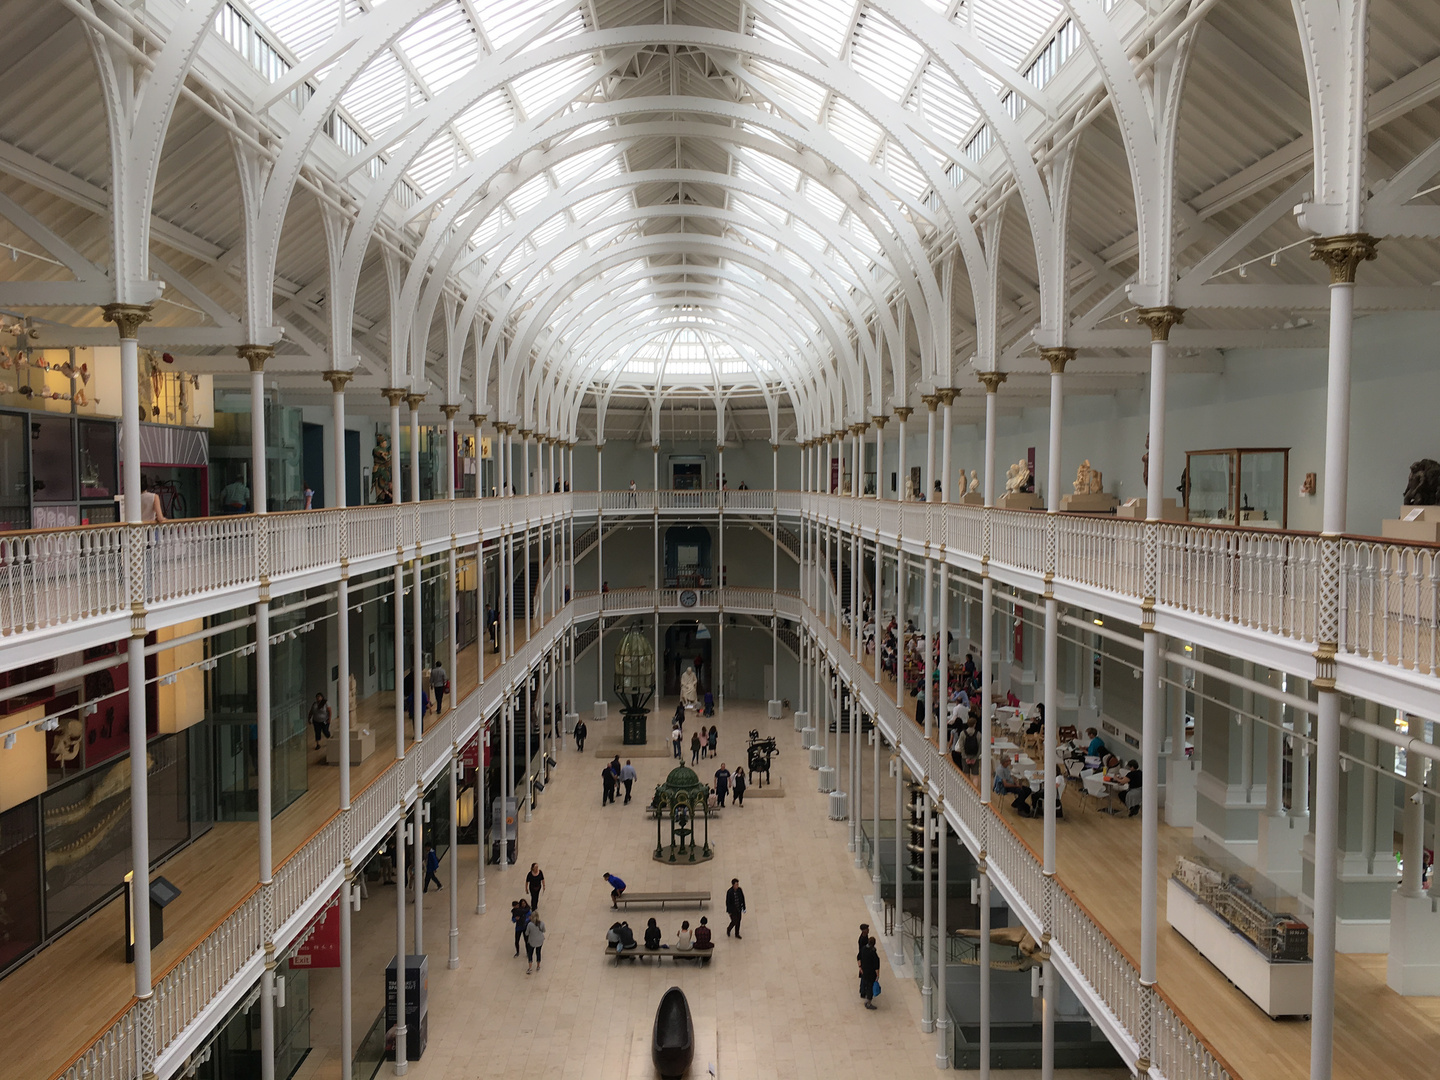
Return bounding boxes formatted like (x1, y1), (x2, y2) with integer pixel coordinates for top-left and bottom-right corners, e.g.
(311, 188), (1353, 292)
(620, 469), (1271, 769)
(831, 616), (1440, 1080)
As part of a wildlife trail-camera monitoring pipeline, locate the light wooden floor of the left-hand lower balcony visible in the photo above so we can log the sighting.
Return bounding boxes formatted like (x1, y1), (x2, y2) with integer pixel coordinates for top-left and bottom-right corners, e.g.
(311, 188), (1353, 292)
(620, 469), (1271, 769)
(0, 619), (555, 1080)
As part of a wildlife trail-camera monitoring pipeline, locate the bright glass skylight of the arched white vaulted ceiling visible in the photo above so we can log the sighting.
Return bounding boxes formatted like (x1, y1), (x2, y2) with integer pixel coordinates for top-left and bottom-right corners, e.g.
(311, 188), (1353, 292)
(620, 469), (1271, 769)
(227, 0), (1082, 392)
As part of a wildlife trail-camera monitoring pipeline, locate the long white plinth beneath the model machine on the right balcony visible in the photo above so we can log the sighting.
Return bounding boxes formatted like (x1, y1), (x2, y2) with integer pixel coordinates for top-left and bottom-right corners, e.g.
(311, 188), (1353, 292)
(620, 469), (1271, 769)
(1165, 878), (1315, 1017)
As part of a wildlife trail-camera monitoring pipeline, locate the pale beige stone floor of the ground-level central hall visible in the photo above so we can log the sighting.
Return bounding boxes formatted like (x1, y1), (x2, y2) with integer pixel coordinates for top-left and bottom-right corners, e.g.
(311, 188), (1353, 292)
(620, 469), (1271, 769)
(298, 703), (1123, 1080)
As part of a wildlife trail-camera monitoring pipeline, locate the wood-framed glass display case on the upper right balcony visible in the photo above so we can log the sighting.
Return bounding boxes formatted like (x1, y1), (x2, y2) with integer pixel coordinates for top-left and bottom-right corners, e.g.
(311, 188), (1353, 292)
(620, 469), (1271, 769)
(1181, 446), (1290, 528)
